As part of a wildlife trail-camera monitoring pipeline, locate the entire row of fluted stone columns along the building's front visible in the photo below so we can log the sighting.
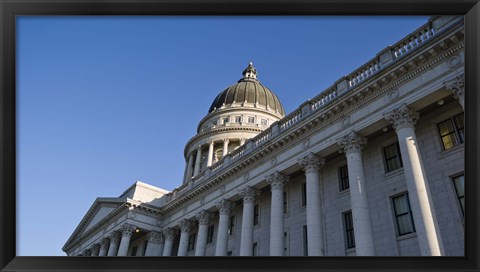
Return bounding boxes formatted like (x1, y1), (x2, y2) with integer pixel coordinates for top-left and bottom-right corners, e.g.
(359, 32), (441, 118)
(78, 104), (450, 256)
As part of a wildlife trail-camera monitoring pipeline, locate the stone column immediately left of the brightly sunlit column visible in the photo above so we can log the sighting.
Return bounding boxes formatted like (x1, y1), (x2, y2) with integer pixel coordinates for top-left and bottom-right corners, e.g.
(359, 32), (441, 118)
(337, 131), (375, 256)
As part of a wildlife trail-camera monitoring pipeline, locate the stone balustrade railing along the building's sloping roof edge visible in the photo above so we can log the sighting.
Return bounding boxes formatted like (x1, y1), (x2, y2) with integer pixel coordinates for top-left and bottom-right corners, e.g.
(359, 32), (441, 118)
(167, 16), (463, 199)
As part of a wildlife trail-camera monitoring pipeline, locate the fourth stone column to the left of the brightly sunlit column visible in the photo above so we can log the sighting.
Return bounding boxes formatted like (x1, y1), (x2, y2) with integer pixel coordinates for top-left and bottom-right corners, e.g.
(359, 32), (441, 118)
(240, 187), (258, 256)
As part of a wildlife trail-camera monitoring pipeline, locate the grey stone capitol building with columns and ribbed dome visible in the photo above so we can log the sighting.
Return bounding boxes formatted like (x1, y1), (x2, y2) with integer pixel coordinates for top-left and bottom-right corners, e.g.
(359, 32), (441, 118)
(63, 16), (465, 256)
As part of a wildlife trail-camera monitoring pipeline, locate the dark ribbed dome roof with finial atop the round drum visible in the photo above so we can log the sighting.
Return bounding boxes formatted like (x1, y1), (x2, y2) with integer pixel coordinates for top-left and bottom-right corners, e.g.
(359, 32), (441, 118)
(208, 62), (285, 116)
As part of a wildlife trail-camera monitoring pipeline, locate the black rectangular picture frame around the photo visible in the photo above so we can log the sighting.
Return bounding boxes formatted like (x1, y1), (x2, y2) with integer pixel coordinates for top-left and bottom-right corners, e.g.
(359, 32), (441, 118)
(0, 0), (480, 271)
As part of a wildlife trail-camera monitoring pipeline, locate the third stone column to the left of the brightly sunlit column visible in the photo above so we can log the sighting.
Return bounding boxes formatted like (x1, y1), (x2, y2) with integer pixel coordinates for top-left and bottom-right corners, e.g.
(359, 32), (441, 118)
(266, 171), (288, 256)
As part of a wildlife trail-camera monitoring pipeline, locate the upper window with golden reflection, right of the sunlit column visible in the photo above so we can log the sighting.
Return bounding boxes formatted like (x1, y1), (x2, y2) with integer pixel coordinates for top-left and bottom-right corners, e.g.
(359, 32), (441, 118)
(437, 113), (465, 150)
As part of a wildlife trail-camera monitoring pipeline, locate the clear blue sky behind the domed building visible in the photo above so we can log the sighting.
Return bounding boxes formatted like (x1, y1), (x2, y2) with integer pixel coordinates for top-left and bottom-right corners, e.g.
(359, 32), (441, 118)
(17, 16), (428, 256)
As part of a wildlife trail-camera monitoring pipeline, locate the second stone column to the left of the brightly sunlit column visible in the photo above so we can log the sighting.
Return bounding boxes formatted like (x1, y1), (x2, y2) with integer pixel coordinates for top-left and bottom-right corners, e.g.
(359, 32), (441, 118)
(298, 153), (325, 256)
